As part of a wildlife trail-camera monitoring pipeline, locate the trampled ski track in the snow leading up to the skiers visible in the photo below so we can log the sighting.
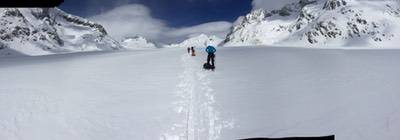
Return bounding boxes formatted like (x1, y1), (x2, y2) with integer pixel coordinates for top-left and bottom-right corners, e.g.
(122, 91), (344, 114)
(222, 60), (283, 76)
(160, 54), (232, 140)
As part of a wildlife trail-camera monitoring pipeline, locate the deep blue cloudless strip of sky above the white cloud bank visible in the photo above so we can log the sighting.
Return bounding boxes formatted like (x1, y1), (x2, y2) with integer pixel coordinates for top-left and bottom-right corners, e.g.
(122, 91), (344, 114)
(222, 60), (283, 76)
(59, 0), (252, 27)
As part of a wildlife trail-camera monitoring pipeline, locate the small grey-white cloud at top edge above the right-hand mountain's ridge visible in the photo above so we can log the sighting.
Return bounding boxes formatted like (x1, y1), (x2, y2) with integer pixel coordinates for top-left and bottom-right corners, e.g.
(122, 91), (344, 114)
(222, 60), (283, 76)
(252, 0), (299, 10)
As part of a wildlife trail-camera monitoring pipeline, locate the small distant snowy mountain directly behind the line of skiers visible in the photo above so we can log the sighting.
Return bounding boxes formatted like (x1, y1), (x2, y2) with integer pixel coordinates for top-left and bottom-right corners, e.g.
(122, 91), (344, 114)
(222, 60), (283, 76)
(165, 34), (223, 47)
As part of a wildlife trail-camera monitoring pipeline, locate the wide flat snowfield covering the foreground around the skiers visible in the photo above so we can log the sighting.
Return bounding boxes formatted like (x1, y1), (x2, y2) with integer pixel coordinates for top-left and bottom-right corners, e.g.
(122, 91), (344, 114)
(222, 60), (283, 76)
(0, 47), (400, 140)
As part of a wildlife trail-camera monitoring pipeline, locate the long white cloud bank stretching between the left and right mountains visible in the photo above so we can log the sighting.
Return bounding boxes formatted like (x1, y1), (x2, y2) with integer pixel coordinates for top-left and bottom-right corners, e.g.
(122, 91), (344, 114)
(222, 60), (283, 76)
(89, 4), (232, 43)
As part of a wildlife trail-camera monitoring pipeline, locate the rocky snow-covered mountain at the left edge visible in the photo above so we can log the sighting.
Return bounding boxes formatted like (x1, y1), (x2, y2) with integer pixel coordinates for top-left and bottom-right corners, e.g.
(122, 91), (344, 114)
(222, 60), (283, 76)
(0, 8), (122, 56)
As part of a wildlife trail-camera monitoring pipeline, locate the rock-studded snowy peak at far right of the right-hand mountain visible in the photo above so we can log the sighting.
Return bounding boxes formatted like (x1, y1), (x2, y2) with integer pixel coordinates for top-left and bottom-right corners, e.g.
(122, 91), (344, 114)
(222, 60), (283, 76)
(296, 0), (400, 46)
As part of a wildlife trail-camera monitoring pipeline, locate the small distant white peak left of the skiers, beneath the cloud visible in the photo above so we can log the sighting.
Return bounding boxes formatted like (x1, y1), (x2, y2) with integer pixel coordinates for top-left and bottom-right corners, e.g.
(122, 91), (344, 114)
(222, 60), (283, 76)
(121, 36), (157, 49)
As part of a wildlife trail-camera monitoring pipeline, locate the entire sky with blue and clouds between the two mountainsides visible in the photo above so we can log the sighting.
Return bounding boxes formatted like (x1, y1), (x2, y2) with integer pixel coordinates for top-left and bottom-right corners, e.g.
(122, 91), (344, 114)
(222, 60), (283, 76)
(59, 0), (290, 44)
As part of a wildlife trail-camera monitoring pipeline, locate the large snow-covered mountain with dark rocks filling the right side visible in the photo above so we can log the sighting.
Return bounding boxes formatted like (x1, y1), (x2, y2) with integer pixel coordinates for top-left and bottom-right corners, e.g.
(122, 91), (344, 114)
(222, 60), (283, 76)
(224, 0), (400, 47)
